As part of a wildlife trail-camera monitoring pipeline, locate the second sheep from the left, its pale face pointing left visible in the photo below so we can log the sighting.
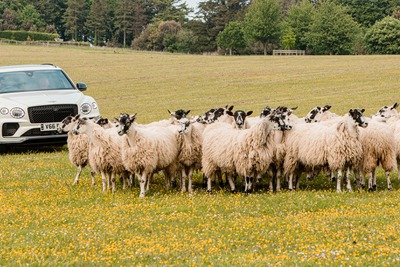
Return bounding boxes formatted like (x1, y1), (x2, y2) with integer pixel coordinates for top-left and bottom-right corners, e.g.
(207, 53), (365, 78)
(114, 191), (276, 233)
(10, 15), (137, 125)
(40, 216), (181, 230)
(73, 115), (126, 192)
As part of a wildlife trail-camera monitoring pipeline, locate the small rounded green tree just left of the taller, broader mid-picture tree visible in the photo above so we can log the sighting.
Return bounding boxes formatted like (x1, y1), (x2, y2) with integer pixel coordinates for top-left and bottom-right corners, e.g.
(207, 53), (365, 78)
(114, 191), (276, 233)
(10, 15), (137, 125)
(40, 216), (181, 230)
(217, 21), (246, 55)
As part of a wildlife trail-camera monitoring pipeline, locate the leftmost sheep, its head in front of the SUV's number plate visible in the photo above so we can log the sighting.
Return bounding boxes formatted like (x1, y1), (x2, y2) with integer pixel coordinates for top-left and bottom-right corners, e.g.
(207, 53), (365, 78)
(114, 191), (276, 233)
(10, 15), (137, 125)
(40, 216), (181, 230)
(58, 116), (96, 185)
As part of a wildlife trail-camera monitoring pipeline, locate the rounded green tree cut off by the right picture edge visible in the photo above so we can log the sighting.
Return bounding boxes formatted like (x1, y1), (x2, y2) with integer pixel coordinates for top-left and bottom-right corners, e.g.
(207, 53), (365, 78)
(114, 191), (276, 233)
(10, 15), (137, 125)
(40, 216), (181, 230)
(364, 16), (400, 54)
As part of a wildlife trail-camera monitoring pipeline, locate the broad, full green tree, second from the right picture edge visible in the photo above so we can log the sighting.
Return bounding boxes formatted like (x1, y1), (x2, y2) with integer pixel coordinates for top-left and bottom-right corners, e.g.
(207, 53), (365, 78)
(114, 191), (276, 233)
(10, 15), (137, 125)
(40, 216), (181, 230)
(305, 1), (360, 55)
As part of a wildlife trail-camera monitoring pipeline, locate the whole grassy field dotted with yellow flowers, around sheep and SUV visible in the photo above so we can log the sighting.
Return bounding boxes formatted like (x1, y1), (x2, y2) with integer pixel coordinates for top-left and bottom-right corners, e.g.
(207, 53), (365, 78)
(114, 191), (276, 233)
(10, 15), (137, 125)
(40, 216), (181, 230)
(0, 45), (400, 266)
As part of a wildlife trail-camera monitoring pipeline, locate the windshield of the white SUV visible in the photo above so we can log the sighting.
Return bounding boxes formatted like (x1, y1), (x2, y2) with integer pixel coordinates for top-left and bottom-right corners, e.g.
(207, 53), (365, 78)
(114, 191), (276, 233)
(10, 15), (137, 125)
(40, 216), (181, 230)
(0, 70), (75, 94)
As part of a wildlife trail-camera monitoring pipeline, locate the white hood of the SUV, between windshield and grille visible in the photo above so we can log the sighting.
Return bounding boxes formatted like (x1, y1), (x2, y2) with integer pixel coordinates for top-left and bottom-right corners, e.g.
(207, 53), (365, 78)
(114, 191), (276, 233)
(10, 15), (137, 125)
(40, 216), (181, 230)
(0, 90), (85, 107)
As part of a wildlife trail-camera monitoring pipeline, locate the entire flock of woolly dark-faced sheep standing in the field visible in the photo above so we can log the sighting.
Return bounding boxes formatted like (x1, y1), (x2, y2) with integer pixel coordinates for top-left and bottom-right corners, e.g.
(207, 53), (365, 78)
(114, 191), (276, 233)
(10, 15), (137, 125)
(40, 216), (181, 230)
(59, 103), (400, 197)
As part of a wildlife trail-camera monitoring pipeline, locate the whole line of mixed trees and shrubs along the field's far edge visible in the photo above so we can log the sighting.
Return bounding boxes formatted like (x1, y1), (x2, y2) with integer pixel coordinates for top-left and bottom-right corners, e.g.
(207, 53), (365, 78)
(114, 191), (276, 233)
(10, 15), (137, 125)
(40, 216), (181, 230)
(0, 0), (400, 55)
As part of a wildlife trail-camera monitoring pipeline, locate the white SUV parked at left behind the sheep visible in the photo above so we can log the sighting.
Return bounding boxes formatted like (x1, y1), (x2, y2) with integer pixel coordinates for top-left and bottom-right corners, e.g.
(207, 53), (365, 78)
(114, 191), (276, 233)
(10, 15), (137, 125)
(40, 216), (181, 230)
(0, 64), (100, 145)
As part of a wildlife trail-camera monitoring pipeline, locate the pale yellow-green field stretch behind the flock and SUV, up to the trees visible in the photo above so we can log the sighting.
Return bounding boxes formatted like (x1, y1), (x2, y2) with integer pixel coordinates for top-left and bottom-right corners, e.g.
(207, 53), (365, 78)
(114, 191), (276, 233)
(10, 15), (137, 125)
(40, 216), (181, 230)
(0, 45), (400, 122)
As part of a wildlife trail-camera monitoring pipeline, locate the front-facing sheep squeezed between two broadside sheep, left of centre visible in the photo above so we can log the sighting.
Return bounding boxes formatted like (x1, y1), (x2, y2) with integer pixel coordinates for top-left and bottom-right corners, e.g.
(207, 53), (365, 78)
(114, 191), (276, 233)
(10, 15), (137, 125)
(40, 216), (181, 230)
(178, 118), (205, 193)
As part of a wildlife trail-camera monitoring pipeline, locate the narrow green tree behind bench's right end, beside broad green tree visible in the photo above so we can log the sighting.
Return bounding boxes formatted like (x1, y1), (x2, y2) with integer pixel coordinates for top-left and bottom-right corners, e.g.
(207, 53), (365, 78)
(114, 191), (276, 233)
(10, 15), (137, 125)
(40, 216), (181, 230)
(286, 0), (315, 50)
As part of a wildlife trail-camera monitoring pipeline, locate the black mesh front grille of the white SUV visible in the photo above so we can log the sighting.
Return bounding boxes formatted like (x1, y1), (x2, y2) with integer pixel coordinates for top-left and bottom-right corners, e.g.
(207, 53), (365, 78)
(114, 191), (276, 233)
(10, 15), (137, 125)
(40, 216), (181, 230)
(28, 105), (78, 123)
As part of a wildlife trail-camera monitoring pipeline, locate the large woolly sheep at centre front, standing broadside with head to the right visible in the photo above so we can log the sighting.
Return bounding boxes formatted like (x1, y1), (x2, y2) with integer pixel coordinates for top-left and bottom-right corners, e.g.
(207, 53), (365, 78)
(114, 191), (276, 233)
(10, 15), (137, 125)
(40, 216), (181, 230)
(202, 109), (291, 193)
